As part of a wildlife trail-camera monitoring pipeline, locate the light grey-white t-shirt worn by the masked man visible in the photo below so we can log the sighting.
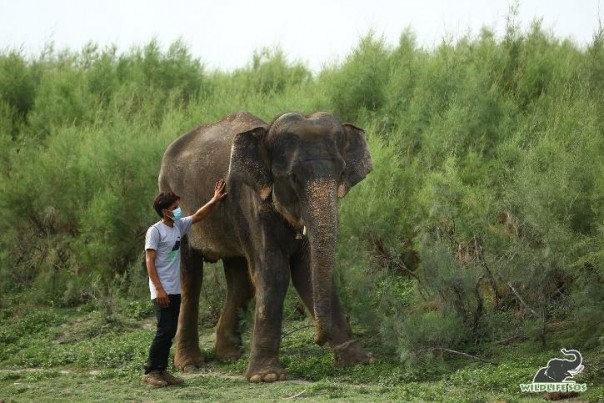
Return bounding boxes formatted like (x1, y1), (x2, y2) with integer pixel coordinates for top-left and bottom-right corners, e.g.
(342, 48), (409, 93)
(145, 216), (193, 299)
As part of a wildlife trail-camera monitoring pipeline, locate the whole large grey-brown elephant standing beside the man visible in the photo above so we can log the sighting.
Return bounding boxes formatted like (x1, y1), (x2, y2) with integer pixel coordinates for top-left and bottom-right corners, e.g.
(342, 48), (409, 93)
(159, 112), (371, 382)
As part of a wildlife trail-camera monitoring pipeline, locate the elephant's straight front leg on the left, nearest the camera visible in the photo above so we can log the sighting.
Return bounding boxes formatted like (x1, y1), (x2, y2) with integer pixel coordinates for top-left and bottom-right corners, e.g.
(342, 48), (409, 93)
(245, 252), (289, 383)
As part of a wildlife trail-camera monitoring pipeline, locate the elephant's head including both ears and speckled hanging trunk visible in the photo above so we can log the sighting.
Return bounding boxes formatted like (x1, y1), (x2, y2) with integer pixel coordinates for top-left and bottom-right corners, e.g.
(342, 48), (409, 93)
(229, 113), (372, 344)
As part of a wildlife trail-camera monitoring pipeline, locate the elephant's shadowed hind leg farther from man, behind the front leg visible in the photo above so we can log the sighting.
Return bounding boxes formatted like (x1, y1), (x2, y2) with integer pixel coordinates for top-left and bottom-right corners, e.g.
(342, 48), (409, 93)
(216, 258), (253, 360)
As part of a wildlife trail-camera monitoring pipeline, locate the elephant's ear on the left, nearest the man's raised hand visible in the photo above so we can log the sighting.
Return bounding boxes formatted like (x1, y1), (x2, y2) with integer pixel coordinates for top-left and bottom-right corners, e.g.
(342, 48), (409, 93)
(229, 127), (273, 200)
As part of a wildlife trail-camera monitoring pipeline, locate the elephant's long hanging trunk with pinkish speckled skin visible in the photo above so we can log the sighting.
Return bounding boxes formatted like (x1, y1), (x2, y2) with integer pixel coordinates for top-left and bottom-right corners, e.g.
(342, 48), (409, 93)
(304, 179), (338, 345)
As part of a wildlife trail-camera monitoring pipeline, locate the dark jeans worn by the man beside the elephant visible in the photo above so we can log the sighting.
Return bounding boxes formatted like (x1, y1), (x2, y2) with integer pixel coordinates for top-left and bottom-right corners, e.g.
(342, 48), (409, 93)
(145, 294), (180, 374)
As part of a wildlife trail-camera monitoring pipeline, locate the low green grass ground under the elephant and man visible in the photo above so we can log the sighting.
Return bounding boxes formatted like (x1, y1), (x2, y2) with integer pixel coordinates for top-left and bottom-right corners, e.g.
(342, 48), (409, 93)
(0, 303), (604, 402)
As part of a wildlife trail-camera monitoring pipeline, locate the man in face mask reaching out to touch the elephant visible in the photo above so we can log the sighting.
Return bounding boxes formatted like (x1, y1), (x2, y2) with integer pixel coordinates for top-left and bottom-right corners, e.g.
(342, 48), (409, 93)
(143, 179), (227, 387)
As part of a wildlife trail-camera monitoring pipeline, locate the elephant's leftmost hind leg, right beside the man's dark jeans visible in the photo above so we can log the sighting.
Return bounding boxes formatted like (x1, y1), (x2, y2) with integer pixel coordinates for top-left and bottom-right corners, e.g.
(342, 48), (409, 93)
(174, 240), (204, 372)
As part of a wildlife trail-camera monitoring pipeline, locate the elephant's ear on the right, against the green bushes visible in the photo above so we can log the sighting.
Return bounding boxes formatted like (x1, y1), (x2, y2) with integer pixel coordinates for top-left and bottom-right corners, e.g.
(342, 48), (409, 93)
(338, 124), (372, 197)
